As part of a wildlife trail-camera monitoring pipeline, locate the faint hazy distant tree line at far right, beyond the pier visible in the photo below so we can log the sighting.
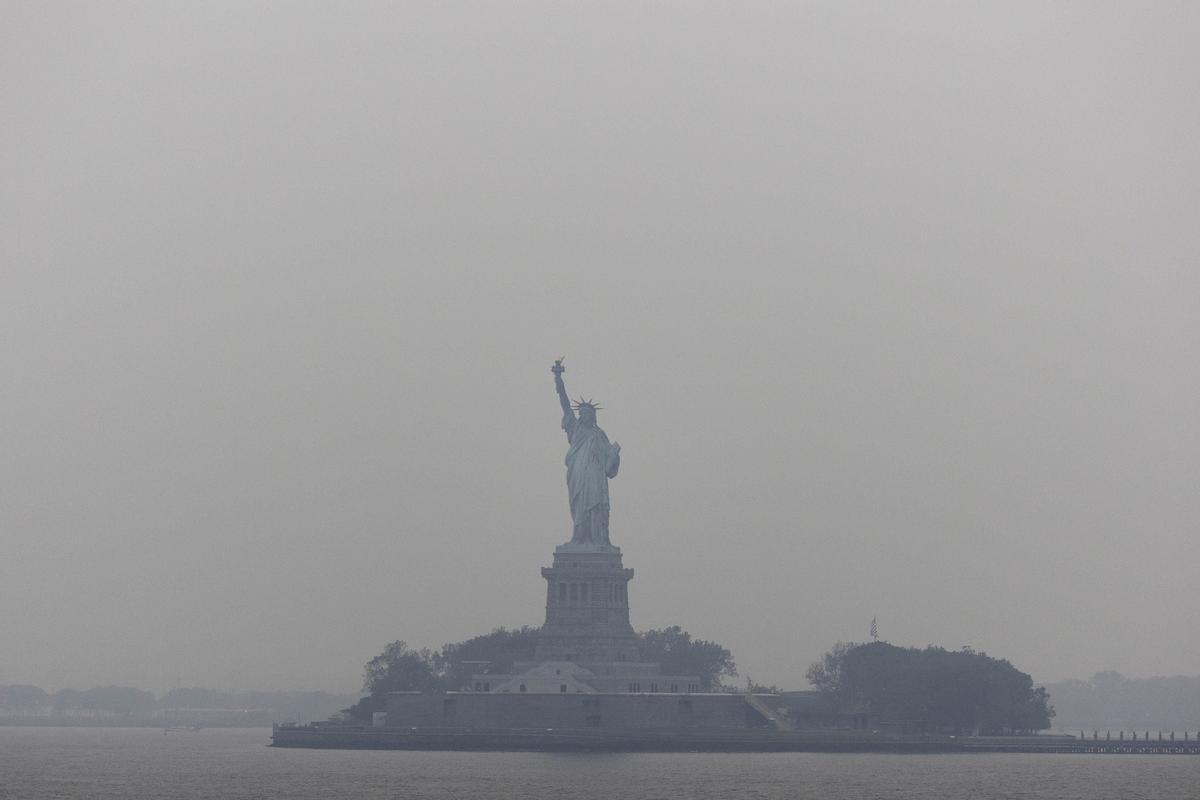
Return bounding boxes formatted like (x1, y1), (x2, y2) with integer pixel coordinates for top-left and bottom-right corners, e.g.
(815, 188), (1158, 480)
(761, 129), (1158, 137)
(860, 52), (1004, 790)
(1046, 672), (1200, 730)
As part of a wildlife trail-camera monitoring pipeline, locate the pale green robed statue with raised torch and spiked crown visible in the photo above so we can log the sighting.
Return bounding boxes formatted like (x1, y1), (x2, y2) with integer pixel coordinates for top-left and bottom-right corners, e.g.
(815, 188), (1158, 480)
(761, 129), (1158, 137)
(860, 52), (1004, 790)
(551, 359), (620, 547)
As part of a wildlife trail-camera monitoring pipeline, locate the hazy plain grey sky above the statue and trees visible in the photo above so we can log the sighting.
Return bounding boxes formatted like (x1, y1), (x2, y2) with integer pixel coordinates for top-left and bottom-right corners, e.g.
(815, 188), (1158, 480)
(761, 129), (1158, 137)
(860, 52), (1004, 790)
(0, 1), (1200, 690)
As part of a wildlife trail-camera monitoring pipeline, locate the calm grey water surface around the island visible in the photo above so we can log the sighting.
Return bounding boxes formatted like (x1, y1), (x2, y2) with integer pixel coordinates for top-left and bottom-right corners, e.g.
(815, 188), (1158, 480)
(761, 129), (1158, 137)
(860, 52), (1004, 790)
(0, 728), (1200, 800)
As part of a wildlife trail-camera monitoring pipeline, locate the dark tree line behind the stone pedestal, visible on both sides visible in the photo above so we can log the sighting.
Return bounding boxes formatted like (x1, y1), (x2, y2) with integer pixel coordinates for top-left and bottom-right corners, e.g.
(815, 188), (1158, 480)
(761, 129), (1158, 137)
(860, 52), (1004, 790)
(344, 626), (738, 721)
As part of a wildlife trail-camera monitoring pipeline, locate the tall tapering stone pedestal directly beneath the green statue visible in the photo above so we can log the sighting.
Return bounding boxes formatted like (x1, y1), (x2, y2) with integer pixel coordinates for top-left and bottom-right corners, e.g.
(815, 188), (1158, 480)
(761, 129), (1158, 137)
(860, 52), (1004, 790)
(535, 545), (641, 664)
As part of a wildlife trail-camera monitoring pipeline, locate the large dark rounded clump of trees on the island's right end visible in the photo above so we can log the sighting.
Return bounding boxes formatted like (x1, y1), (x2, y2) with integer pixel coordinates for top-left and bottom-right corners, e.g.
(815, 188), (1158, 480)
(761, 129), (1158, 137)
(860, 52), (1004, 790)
(808, 642), (1055, 733)
